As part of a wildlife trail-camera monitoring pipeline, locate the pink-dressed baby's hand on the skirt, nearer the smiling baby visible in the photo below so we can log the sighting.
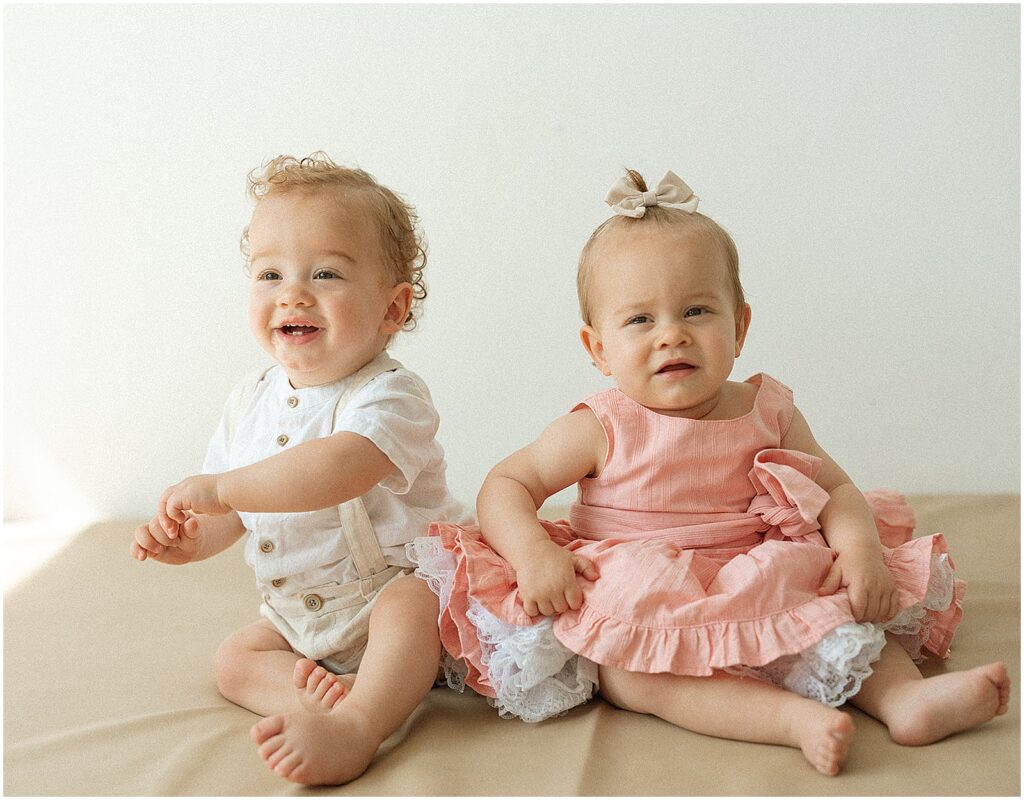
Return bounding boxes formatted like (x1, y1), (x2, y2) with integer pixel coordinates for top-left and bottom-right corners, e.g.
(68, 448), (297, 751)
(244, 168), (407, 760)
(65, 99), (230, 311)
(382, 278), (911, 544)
(516, 540), (597, 617)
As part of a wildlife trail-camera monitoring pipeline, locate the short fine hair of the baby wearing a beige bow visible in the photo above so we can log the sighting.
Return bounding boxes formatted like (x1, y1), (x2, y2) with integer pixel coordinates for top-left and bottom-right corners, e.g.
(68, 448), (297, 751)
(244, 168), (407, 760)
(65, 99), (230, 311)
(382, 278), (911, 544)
(577, 169), (746, 325)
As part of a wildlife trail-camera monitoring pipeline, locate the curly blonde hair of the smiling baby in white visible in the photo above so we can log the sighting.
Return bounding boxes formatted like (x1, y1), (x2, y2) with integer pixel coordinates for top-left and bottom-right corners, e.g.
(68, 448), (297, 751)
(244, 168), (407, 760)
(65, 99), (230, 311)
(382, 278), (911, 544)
(240, 151), (427, 331)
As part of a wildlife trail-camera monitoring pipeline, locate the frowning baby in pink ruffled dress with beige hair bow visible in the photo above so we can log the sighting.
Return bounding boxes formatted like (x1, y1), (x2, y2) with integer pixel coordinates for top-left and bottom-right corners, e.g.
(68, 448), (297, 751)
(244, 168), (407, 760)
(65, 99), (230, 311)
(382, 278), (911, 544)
(409, 170), (1010, 775)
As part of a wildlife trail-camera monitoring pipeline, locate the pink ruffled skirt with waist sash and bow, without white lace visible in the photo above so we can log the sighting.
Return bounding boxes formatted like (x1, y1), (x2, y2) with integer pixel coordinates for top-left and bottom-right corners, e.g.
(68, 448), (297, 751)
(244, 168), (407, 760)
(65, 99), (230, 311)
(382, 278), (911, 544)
(413, 449), (965, 698)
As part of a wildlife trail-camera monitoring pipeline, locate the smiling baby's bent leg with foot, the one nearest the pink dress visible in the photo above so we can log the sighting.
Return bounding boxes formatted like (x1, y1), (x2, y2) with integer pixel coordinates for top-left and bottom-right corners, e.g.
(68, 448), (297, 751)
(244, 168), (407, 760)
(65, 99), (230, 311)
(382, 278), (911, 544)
(250, 576), (440, 786)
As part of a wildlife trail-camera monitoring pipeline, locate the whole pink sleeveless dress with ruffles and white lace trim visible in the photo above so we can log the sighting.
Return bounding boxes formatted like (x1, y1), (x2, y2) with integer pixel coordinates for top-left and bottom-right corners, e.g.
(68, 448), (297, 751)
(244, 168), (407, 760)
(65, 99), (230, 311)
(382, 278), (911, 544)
(409, 374), (965, 721)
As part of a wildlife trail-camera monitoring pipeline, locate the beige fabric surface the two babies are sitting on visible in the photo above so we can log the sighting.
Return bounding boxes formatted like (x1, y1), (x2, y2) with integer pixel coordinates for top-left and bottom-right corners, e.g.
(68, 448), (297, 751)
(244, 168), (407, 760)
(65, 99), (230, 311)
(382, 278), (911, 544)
(4, 496), (1021, 796)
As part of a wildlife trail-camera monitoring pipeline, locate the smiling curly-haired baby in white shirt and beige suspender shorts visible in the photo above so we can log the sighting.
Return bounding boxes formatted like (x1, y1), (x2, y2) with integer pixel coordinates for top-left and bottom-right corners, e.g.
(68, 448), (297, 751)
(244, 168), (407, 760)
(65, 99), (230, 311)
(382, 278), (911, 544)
(131, 154), (469, 785)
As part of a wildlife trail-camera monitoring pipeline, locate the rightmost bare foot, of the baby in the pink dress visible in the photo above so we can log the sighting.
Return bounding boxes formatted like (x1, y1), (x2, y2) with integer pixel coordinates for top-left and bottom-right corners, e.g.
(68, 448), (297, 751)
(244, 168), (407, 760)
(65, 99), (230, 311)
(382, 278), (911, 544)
(889, 662), (1010, 747)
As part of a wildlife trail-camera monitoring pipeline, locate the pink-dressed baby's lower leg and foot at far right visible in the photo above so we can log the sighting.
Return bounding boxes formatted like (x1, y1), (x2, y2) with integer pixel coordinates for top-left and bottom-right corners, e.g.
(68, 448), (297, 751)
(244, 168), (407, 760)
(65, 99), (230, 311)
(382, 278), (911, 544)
(850, 636), (1010, 746)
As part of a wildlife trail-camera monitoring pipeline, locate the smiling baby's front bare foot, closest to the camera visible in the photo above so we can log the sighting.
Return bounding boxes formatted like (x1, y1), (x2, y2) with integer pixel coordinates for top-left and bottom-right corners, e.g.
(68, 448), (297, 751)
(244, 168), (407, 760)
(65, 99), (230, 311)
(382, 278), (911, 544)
(249, 704), (380, 786)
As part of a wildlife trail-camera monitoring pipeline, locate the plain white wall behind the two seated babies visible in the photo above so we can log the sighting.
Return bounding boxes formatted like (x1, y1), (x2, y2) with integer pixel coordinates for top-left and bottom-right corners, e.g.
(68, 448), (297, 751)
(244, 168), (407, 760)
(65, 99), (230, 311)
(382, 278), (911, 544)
(3, 5), (1020, 518)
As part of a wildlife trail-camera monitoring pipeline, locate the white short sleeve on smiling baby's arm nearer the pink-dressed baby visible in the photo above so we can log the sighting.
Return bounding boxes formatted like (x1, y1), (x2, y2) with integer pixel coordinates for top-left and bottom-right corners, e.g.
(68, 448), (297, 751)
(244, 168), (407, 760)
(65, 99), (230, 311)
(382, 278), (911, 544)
(334, 369), (440, 495)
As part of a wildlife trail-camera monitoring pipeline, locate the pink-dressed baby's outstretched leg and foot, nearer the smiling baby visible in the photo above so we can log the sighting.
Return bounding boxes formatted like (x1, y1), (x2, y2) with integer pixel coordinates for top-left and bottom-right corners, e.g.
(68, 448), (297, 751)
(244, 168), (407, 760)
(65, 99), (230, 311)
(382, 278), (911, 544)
(600, 667), (853, 775)
